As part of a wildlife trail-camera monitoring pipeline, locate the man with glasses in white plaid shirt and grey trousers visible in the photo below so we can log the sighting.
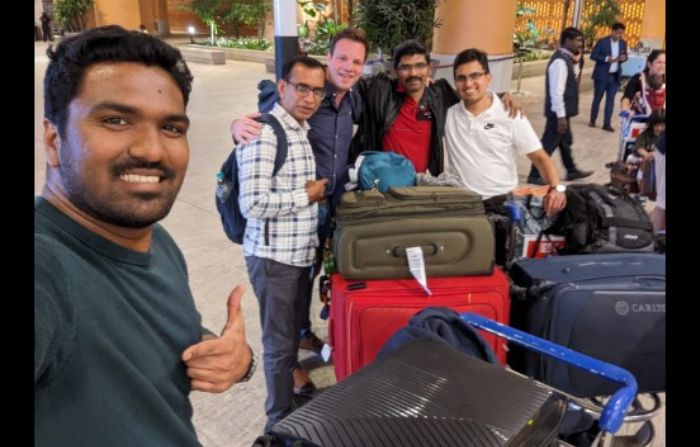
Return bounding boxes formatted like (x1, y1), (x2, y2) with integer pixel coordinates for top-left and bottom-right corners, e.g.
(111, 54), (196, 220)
(236, 57), (328, 431)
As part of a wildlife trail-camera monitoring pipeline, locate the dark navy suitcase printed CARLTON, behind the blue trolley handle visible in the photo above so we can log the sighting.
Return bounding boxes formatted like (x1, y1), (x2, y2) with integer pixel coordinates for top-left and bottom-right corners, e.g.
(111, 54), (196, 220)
(508, 253), (666, 397)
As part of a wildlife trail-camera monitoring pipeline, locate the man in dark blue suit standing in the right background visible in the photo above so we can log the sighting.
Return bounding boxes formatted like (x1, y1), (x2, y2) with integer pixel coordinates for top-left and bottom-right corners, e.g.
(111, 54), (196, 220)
(588, 22), (627, 132)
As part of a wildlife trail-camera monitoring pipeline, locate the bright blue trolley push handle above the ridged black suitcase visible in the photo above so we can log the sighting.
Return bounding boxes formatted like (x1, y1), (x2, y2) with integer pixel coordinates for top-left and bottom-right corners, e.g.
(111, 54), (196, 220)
(460, 312), (637, 433)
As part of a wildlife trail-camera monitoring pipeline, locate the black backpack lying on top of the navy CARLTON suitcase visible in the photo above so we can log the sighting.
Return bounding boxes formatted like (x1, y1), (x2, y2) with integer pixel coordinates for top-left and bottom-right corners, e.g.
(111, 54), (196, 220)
(546, 184), (655, 254)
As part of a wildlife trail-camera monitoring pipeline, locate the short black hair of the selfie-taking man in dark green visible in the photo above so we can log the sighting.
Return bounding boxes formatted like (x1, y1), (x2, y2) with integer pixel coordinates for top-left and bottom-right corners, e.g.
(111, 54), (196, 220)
(44, 25), (193, 136)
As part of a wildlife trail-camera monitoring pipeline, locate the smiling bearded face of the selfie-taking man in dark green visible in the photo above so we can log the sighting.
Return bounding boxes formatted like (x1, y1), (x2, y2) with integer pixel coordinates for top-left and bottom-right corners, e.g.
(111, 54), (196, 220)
(44, 62), (189, 228)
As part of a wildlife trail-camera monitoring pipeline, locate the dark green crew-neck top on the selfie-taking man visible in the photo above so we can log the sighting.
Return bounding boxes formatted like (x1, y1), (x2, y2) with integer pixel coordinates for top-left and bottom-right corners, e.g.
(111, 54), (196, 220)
(34, 198), (202, 447)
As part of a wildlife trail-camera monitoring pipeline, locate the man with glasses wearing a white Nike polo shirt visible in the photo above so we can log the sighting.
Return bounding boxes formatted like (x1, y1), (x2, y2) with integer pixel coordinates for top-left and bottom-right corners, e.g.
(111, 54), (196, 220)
(445, 48), (566, 263)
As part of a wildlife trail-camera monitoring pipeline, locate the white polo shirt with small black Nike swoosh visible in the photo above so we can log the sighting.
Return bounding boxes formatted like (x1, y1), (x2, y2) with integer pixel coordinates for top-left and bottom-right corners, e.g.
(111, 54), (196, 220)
(445, 92), (542, 200)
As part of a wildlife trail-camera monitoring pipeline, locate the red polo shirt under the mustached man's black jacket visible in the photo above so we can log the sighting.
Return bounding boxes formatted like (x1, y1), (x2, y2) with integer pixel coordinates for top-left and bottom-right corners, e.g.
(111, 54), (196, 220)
(382, 95), (432, 172)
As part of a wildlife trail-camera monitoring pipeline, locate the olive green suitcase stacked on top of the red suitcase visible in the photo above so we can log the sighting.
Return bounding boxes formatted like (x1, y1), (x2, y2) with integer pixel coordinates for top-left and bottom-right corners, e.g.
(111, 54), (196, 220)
(333, 186), (495, 279)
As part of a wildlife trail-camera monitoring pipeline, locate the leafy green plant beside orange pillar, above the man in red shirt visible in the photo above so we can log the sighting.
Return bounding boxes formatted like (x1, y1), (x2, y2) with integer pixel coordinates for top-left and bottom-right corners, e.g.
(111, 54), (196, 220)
(353, 0), (441, 58)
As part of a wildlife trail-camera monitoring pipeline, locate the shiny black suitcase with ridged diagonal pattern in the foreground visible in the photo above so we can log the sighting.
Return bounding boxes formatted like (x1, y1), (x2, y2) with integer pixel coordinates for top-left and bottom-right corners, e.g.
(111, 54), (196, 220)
(260, 339), (567, 447)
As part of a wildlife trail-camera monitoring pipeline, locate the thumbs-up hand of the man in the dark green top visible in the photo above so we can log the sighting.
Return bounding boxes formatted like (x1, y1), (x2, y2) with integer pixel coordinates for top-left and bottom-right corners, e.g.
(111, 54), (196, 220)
(182, 285), (252, 393)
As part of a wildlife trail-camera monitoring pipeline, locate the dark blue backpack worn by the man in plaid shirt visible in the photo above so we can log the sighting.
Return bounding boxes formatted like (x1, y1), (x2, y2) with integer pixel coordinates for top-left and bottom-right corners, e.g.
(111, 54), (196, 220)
(216, 113), (288, 244)
